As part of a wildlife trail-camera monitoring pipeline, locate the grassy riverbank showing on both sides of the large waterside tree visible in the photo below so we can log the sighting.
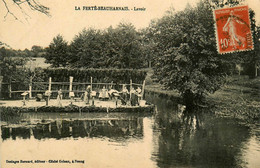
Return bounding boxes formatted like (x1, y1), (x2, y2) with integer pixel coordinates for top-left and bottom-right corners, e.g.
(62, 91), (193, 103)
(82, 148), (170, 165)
(145, 71), (260, 123)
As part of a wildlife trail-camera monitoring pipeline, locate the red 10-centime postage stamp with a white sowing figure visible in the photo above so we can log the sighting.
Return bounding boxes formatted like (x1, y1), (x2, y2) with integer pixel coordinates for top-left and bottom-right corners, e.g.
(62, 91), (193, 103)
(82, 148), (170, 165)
(214, 6), (254, 54)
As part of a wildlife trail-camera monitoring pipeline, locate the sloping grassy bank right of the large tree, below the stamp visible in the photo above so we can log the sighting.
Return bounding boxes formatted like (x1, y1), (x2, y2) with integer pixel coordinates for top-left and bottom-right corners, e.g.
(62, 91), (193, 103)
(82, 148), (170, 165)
(207, 76), (260, 122)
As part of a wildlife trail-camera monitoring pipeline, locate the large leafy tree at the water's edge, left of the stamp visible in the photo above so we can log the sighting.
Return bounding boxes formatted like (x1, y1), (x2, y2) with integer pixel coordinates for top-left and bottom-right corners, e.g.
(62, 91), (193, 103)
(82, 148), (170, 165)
(150, 2), (229, 108)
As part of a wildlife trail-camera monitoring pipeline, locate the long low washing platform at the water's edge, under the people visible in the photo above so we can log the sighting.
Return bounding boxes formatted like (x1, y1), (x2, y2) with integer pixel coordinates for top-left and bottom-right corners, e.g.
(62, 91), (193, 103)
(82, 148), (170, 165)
(0, 99), (155, 114)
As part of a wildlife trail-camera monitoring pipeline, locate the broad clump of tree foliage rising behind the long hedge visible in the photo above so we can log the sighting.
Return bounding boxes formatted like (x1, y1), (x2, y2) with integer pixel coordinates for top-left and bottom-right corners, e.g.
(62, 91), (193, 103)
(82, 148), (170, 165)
(69, 23), (146, 68)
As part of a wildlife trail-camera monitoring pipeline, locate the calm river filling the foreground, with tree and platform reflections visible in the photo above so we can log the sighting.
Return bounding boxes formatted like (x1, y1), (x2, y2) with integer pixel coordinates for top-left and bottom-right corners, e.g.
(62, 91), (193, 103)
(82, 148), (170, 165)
(1, 94), (260, 168)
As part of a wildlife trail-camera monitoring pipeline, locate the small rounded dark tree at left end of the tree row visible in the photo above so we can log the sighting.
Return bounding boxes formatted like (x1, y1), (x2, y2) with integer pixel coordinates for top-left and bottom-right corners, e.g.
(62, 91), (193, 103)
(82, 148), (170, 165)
(44, 35), (69, 67)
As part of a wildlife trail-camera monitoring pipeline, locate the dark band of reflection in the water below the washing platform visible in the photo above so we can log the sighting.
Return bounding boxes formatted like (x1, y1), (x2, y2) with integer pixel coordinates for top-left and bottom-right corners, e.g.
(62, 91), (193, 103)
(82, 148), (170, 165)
(1, 118), (143, 140)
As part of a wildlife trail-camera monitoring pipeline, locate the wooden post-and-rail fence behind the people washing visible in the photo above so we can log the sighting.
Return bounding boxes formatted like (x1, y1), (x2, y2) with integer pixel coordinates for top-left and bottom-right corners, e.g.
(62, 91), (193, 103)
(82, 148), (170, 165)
(0, 76), (145, 99)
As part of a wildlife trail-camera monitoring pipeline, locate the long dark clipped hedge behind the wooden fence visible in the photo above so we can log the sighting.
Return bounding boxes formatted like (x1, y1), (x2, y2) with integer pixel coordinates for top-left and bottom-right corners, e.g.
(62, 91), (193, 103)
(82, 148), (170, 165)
(34, 68), (146, 84)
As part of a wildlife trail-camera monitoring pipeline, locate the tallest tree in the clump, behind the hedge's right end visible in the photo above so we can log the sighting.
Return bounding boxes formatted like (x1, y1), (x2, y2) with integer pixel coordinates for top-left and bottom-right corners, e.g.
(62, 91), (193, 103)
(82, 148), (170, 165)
(104, 23), (144, 69)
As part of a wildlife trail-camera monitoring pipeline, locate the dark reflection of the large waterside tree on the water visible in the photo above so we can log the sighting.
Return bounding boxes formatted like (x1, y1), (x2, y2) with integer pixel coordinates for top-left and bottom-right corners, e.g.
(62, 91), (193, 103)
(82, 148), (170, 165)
(155, 109), (249, 167)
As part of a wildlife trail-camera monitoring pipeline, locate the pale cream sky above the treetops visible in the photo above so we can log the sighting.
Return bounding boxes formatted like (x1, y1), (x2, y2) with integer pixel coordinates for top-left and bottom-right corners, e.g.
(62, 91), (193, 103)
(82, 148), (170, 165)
(0, 0), (260, 50)
